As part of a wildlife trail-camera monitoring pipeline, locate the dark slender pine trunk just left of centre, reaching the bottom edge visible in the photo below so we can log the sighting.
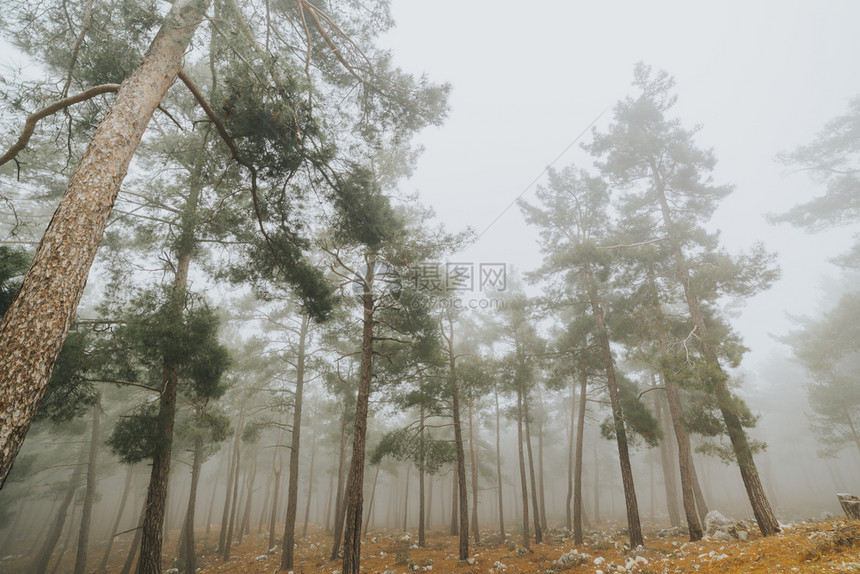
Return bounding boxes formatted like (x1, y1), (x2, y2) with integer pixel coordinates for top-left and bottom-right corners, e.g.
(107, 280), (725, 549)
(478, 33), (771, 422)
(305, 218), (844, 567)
(342, 262), (376, 574)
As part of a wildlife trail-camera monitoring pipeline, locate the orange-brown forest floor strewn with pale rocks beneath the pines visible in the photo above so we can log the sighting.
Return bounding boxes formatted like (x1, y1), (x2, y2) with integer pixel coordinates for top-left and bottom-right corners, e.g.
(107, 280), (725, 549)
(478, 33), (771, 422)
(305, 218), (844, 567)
(10, 518), (860, 574)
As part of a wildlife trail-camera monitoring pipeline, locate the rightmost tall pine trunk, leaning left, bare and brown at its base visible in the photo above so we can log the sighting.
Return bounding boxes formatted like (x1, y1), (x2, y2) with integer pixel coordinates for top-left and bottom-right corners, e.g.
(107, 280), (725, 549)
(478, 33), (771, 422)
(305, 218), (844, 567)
(651, 164), (779, 536)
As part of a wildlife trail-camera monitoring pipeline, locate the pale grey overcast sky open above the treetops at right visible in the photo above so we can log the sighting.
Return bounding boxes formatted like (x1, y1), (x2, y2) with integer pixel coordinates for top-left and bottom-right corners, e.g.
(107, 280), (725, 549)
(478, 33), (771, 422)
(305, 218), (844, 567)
(385, 0), (860, 382)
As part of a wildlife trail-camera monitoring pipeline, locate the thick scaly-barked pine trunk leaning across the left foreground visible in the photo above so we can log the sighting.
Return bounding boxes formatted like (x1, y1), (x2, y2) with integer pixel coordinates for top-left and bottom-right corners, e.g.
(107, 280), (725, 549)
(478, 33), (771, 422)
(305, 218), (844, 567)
(0, 0), (209, 490)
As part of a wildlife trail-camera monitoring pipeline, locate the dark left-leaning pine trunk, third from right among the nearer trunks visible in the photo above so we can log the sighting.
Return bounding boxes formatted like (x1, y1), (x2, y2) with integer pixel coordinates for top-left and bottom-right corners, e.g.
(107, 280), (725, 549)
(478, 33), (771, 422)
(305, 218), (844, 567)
(584, 266), (645, 548)
